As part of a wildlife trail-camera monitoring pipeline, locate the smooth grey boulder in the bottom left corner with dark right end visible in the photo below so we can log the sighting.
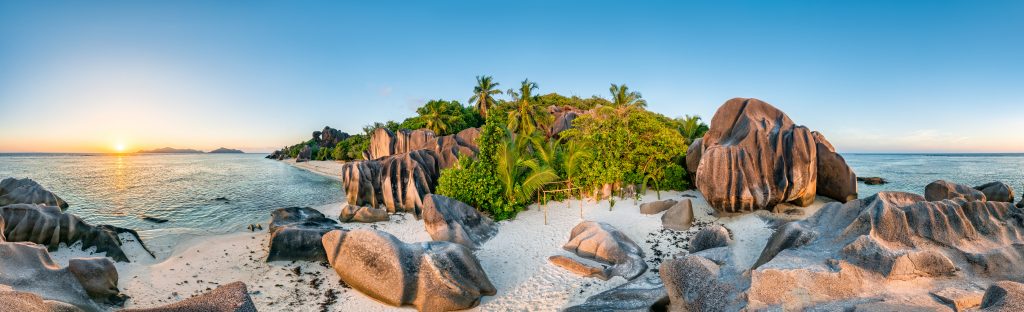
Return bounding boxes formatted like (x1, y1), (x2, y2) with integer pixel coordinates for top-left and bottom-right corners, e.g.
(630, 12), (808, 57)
(0, 242), (118, 311)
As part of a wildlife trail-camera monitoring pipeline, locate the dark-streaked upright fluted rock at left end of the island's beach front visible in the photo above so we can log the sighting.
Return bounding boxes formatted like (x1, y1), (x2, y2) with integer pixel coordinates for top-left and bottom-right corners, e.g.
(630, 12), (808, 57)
(341, 149), (441, 217)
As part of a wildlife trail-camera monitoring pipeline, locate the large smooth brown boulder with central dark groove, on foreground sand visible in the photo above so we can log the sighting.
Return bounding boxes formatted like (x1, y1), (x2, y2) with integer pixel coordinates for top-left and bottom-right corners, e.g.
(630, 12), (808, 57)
(324, 229), (497, 311)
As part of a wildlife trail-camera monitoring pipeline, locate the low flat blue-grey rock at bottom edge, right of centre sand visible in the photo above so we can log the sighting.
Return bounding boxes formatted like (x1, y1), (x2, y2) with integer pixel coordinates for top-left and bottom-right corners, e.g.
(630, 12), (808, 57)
(564, 276), (669, 312)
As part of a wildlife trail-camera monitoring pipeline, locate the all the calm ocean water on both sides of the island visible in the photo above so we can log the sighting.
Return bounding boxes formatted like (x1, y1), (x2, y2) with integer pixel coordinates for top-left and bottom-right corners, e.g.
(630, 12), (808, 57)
(0, 153), (1024, 250)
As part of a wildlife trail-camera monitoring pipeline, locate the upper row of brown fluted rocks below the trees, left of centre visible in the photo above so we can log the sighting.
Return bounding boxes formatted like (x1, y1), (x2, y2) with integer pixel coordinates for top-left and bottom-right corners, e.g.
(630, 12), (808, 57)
(365, 128), (480, 169)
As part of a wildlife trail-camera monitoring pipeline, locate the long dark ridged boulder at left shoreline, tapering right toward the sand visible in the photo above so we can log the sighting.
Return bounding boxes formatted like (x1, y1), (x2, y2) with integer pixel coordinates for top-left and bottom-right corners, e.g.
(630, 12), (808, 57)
(0, 204), (153, 262)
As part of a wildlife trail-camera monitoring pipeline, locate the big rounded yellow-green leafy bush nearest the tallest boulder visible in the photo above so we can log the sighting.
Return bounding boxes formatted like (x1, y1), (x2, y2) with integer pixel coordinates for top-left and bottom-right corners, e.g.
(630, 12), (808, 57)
(563, 105), (686, 187)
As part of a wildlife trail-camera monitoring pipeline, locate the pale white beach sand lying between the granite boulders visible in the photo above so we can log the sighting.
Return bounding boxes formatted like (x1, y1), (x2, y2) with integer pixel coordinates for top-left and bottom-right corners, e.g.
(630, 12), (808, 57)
(53, 186), (825, 311)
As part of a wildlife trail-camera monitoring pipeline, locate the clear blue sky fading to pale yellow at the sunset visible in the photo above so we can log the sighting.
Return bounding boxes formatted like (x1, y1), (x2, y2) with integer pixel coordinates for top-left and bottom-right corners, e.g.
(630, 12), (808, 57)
(0, 0), (1024, 152)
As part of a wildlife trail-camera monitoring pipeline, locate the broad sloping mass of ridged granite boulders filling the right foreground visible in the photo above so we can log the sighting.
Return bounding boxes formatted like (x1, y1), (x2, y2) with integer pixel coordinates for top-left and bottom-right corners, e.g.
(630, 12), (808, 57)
(660, 181), (1024, 311)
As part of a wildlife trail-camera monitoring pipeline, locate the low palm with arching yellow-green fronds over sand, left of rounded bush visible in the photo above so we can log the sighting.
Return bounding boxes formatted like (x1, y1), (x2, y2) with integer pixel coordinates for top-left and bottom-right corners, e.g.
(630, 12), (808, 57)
(495, 126), (558, 203)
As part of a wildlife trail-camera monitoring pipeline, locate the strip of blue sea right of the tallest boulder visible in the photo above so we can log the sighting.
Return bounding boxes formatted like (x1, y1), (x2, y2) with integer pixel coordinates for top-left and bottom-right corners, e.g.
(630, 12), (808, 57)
(843, 153), (1024, 200)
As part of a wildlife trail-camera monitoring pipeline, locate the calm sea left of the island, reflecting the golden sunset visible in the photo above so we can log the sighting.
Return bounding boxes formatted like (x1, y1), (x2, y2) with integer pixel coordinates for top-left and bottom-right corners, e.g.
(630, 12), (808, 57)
(0, 153), (344, 245)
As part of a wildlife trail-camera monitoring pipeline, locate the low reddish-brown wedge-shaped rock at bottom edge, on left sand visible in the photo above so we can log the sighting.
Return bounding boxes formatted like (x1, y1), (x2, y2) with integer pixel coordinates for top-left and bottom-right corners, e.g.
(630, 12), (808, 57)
(121, 281), (256, 312)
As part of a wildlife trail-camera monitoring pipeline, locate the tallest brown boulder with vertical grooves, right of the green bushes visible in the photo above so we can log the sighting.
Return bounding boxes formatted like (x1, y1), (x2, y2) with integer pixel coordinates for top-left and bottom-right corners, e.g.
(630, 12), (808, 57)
(687, 98), (857, 213)
